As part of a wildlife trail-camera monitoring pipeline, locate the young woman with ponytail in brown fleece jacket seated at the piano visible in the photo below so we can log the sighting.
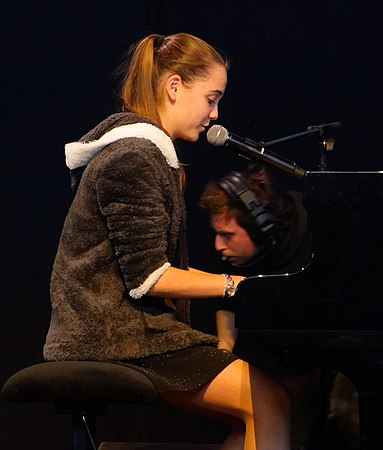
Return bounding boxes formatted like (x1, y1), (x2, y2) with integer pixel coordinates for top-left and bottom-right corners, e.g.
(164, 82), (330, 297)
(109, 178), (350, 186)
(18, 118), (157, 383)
(44, 33), (289, 450)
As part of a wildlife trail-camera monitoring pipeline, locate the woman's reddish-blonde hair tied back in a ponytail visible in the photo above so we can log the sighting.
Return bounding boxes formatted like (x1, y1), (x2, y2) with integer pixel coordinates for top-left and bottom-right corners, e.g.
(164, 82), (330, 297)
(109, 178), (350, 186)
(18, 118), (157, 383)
(120, 33), (229, 125)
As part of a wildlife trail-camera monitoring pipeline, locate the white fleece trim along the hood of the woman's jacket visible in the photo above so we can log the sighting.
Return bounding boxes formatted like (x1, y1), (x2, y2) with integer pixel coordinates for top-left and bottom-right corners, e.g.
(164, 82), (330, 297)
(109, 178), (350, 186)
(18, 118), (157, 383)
(65, 122), (178, 169)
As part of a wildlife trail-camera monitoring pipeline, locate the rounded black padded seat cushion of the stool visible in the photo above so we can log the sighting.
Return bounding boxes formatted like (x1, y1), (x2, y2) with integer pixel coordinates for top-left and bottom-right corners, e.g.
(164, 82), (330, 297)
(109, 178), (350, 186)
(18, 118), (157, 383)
(1, 361), (157, 404)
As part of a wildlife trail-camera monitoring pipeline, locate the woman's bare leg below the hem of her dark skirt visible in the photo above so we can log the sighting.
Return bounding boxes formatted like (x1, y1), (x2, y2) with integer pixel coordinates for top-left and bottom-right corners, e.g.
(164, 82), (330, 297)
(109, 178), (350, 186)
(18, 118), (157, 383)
(164, 359), (290, 450)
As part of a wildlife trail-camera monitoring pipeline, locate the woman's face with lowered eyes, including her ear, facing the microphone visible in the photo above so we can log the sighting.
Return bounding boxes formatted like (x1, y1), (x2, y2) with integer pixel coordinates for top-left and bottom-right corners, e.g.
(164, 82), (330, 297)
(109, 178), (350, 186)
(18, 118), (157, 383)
(160, 64), (227, 142)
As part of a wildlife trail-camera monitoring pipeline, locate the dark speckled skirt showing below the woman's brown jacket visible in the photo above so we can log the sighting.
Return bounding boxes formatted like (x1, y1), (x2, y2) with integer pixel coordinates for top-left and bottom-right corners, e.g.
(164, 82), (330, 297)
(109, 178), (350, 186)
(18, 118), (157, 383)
(119, 345), (238, 393)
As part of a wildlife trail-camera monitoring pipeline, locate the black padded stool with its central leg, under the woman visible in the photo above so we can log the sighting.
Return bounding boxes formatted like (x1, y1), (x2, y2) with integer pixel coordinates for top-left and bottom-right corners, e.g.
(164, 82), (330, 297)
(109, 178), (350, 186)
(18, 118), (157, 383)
(1, 361), (157, 450)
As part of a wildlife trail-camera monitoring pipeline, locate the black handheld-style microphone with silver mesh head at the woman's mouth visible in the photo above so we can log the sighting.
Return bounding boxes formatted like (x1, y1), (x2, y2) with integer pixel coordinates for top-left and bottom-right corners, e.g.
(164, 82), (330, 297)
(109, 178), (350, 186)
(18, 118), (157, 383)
(207, 125), (306, 179)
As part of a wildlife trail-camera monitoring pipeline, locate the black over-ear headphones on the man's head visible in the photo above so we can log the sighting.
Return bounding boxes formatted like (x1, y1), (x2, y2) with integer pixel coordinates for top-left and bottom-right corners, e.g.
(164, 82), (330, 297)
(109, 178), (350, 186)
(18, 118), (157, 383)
(217, 172), (278, 249)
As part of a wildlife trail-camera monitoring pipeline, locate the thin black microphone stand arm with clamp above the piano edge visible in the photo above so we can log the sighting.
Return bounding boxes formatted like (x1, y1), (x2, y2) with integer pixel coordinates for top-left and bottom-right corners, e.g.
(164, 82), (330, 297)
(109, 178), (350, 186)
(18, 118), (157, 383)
(250, 122), (342, 170)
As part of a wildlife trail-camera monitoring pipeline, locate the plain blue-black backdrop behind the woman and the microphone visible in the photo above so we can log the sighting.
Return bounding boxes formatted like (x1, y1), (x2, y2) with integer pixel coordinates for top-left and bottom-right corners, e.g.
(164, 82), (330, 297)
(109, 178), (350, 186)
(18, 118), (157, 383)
(0, 0), (383, 450)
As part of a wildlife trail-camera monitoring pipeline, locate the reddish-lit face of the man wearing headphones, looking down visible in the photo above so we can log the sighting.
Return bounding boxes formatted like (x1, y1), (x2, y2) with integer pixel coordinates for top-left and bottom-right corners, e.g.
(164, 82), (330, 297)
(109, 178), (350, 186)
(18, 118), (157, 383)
(210, 212), (259, 266)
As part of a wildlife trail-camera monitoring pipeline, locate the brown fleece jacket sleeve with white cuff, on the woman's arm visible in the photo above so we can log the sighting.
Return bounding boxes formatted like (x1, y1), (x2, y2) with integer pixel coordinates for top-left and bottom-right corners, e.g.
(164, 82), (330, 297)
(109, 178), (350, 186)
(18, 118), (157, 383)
(95, 138), (170, 298)
